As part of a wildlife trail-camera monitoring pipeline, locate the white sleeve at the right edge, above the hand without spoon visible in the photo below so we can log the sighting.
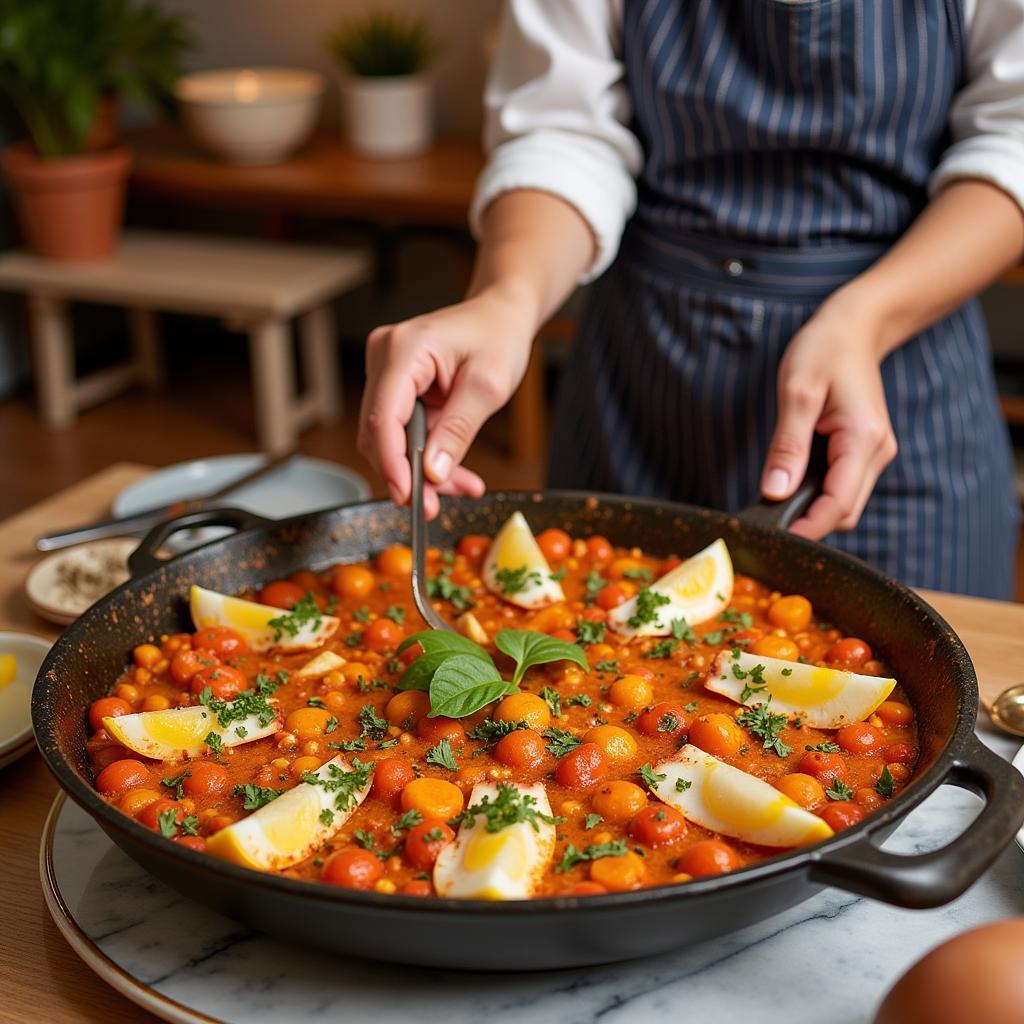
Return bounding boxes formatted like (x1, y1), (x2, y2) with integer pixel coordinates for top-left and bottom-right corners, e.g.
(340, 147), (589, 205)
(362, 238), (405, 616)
(930, 0), (1024, 209)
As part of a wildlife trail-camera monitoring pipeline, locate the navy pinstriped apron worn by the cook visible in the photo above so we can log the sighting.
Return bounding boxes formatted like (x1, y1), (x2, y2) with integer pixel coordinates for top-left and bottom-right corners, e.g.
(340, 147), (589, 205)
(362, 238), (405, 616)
(549, 0), (1018, 598)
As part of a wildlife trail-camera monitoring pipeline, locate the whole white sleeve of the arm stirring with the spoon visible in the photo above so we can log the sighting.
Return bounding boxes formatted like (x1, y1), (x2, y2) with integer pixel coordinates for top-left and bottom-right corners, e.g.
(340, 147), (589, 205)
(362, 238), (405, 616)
(470, 0), (642, 281)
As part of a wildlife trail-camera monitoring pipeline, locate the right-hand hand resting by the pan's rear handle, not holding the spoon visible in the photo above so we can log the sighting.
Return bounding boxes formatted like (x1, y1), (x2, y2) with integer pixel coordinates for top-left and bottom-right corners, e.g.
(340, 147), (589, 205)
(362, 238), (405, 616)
(761, 293), (896, 540)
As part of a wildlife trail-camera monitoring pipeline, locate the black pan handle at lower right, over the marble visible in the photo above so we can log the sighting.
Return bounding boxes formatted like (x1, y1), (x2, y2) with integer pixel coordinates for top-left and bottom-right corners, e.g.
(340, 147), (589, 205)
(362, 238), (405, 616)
(810, 736), (1024, 909)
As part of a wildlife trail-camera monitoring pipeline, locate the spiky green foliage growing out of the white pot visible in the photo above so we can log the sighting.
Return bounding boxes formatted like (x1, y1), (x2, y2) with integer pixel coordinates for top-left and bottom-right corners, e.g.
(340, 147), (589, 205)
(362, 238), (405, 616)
(328, 10), (437, 78)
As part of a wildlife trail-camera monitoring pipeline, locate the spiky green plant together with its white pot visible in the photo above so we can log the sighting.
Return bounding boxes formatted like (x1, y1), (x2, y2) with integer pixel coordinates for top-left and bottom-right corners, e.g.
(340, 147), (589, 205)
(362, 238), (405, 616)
(328, 10), (437, 157)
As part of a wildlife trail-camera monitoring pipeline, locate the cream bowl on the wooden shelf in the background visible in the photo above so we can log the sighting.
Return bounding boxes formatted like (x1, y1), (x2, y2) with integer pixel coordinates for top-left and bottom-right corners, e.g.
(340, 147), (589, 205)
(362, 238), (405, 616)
(174, 68), (324, 165)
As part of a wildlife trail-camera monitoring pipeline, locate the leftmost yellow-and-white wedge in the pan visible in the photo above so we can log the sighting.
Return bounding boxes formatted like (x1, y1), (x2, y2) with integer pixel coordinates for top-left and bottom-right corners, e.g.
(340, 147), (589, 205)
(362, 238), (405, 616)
(103, 705), (281, 761)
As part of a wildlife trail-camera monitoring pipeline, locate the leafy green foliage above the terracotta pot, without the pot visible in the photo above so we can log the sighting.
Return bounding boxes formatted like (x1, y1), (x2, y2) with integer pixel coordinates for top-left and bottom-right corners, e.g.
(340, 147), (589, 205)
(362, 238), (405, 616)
(0, 0), (191, 159)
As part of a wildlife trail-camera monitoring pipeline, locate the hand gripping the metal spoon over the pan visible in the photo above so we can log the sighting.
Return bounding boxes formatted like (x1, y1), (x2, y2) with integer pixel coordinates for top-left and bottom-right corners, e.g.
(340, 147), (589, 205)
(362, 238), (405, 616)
(357, 290), (536, 519)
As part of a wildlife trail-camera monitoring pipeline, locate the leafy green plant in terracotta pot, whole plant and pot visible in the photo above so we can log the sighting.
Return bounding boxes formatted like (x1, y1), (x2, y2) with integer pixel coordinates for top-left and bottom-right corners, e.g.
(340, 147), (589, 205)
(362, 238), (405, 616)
(0, 0), (189, 260)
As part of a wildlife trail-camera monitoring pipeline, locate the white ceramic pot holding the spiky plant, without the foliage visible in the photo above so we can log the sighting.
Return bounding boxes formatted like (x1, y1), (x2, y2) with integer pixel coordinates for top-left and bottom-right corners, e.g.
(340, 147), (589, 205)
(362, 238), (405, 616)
(341, 75), (434, 157)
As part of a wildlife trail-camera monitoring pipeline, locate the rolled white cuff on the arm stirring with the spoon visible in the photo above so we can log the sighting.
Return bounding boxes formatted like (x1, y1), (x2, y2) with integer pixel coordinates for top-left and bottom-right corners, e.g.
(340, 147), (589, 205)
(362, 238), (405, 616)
(469, 129), (636, 283)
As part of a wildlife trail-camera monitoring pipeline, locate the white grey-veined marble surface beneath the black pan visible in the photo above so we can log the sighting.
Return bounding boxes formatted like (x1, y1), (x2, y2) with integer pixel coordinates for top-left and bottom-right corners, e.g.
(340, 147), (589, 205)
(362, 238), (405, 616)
(46, 720), (1024, 1024)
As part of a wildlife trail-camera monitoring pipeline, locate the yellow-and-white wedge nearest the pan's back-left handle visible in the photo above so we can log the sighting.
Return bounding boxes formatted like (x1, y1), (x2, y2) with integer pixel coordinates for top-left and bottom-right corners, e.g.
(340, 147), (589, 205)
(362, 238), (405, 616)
(188, 586), (340, 651)
